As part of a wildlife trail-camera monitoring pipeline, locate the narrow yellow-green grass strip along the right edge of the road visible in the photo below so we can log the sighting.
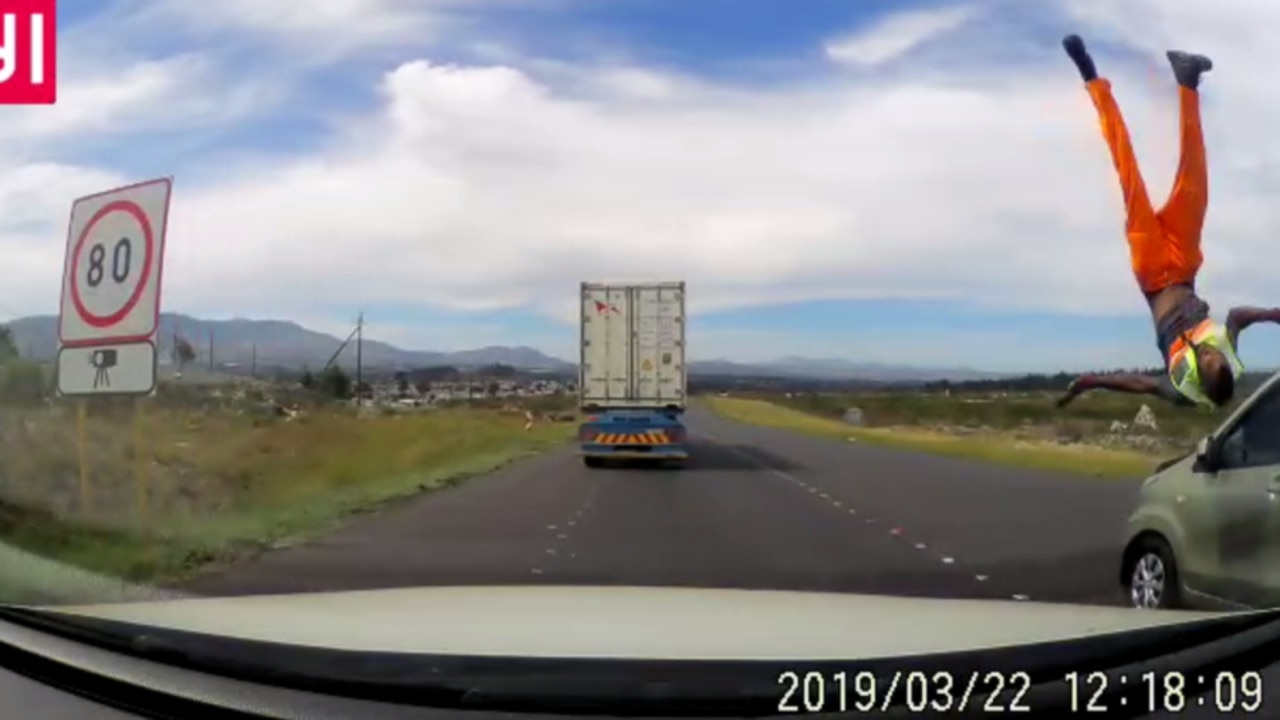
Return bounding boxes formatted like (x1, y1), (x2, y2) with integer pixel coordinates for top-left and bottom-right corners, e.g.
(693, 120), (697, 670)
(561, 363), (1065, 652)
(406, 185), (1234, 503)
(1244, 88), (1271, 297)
(707, 396), (1167, 478)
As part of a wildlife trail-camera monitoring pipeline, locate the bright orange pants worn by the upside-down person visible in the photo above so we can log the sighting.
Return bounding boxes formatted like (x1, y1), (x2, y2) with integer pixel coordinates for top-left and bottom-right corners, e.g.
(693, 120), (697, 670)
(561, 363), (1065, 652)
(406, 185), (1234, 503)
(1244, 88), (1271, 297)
(1084, 78), (1208, 295)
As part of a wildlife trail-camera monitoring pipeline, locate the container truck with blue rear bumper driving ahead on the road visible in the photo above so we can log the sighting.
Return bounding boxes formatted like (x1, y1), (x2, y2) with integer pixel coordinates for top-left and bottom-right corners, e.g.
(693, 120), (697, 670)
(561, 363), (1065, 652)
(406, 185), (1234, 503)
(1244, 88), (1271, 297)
(577, 282), (689, 468)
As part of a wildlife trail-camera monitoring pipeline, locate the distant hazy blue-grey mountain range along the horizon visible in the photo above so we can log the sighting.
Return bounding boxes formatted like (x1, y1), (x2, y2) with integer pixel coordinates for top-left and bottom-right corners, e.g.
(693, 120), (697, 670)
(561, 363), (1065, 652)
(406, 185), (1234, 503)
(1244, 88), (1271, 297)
(0, 313), (1009, 382)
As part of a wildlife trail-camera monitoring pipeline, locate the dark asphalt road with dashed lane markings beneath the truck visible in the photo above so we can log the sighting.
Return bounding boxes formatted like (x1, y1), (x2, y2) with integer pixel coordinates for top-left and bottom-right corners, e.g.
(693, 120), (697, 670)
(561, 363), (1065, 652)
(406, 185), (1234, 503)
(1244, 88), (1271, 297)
(183, 399), (1137, 603)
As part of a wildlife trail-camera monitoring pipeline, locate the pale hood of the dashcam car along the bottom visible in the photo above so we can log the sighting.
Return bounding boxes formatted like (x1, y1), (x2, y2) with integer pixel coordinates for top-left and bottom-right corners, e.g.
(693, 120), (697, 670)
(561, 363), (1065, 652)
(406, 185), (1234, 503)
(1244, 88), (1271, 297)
(47, 587), (1216, 660)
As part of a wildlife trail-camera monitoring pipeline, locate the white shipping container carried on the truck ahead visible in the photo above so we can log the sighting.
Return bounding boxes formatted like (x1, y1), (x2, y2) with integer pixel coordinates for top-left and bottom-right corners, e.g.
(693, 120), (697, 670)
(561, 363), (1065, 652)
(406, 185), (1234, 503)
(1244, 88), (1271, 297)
(579, 282), (687, 409)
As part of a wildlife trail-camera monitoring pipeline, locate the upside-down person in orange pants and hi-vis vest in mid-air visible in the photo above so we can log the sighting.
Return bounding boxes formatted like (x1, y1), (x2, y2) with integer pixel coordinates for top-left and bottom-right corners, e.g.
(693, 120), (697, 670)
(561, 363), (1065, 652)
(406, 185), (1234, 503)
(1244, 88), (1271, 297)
(1057, 35), (1280, 407)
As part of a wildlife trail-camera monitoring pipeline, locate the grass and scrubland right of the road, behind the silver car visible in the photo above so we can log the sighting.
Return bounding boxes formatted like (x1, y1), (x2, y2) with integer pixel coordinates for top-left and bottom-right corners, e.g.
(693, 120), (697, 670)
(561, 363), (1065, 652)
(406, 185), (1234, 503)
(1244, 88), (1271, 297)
(707, 380), (1245, 478)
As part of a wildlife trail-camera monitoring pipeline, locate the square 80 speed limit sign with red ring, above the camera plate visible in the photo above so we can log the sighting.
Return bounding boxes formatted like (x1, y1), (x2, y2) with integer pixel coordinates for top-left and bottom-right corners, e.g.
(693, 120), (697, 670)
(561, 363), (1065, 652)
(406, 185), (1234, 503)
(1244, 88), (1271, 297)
(58, 178), (173, 347)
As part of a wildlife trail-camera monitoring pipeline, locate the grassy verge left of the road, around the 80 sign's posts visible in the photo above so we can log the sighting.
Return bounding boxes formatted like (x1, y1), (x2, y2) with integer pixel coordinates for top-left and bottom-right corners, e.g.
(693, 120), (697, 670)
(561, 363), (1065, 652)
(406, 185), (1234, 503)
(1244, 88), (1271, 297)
(0, 389), (575, 601)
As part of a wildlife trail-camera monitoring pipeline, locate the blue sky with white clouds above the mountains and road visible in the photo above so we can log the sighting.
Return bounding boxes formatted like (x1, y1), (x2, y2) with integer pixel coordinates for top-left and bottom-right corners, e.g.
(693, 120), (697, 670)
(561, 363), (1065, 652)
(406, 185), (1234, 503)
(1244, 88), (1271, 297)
(0, 0), (1280, 372)
